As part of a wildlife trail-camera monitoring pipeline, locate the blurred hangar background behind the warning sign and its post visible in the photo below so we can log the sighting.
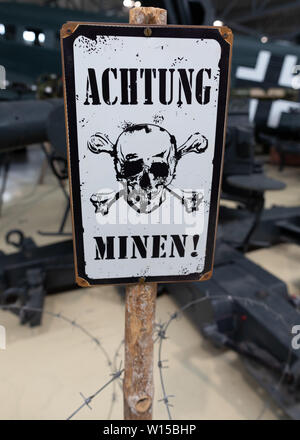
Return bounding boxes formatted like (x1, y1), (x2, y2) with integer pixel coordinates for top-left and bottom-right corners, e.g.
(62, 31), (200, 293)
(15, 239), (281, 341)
(0, 0), (300, 420)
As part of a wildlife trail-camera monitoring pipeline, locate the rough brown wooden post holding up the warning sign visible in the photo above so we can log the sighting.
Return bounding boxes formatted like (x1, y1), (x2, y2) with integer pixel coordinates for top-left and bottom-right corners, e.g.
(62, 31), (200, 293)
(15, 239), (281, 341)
(123, 7), (167, 420)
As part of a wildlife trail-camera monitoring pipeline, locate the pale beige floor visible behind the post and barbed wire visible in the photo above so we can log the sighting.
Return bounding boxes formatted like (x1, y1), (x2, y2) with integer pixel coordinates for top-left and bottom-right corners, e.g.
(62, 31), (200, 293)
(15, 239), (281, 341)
(0, 149), (300, 419)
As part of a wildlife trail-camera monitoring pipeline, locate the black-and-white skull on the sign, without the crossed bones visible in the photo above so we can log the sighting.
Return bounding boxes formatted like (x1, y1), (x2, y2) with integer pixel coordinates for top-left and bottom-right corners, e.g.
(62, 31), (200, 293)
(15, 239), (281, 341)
(115, 124), (177, 213)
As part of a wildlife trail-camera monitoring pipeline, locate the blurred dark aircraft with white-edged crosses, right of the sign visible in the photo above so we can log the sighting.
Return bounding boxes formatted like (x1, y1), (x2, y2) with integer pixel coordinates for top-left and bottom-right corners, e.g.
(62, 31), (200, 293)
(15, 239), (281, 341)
(231, 35), (300, 136)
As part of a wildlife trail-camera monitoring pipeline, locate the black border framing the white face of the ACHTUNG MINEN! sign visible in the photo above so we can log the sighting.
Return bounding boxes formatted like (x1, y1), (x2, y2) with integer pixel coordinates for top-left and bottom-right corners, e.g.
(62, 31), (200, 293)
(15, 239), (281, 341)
(62, 22), (231, 285)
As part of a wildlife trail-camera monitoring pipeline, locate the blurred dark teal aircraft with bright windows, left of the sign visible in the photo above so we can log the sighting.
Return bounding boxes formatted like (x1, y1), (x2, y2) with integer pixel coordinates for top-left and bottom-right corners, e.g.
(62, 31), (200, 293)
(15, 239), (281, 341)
(0, 2), (124, 100)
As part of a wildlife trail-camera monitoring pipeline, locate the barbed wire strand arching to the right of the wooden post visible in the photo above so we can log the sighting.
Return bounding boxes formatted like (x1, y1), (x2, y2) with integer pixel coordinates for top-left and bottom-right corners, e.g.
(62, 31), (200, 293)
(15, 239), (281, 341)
(154, 291), (292, 420)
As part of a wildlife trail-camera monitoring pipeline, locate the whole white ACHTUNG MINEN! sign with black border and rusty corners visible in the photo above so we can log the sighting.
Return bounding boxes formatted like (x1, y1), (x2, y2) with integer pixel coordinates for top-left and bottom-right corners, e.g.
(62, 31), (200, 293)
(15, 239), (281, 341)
(62, 23), (231, 285)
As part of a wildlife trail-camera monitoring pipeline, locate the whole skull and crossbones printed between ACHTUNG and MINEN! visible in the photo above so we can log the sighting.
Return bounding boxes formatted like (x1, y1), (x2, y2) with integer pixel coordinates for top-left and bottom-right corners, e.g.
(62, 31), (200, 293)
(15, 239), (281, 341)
(87, 124), (208, 215)
